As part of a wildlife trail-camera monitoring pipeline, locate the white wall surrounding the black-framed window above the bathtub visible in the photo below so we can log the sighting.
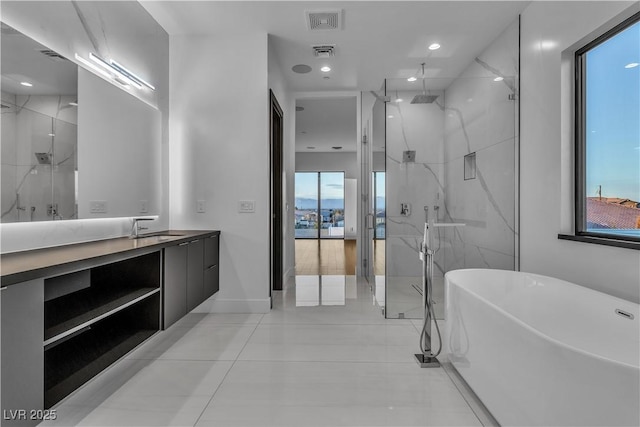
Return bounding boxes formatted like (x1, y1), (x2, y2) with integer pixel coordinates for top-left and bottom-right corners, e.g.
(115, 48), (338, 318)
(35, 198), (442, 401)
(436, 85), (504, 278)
(520, 1), (640, 302)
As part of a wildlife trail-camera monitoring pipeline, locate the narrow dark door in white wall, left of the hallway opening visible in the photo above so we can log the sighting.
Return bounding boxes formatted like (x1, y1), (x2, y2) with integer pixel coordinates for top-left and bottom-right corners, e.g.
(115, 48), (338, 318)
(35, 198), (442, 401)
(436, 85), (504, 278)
(269, 91), (283, 294)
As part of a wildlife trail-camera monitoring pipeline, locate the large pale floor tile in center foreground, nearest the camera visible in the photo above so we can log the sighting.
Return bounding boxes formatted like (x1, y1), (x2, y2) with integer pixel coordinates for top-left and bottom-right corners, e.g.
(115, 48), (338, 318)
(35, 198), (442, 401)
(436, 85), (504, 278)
(198, 361), (480, 426)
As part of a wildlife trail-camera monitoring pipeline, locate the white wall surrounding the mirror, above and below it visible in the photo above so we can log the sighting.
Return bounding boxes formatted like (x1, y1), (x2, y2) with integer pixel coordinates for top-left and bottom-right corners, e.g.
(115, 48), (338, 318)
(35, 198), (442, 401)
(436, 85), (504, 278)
(0, 0), (169, 252)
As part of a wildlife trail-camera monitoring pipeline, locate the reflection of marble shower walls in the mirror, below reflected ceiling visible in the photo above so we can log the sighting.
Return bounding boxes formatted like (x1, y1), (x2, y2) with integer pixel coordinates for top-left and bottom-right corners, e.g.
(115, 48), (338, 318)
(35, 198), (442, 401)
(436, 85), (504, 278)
(1, 92), (78, 223)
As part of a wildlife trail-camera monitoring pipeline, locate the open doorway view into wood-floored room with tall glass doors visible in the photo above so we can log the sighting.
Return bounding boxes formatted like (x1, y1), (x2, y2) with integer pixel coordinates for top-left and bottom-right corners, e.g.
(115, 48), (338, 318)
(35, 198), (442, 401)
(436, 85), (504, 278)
(294, 93), (359, 275)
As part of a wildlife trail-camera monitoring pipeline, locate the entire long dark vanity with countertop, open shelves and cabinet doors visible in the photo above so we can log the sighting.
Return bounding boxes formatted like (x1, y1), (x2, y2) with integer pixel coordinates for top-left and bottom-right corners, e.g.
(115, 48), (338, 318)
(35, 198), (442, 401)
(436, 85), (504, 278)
(0, 231), (219, 426)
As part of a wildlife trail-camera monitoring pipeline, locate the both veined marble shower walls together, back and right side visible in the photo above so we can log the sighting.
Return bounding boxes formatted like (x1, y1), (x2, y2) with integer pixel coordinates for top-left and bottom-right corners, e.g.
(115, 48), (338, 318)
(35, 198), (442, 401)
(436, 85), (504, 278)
(384, 21), (519, 318)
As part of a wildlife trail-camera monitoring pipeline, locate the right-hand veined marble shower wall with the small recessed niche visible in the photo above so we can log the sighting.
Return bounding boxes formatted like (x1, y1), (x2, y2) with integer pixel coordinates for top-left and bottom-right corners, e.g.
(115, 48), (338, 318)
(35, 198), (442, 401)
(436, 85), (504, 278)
(444, 21), (519, 271)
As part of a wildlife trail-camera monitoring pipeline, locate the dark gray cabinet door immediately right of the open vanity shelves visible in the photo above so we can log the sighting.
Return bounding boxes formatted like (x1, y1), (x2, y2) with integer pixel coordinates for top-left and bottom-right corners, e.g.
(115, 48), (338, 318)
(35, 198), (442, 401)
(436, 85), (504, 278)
(164, 243), (188, 329)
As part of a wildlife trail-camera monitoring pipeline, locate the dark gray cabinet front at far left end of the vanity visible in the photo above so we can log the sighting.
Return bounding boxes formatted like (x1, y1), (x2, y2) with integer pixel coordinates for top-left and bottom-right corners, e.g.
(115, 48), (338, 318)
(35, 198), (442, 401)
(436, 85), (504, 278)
(0, 279), (44, 426)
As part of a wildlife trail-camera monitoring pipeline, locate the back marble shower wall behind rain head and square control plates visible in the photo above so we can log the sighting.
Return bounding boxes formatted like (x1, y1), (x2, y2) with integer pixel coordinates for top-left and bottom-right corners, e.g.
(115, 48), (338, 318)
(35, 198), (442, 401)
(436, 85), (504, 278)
(386, 88), (444, 318)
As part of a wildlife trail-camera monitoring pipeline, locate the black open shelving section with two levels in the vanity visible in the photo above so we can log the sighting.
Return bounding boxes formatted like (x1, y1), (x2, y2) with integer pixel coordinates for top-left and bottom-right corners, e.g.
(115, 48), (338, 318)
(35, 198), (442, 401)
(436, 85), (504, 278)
(42, 251), (161, 408)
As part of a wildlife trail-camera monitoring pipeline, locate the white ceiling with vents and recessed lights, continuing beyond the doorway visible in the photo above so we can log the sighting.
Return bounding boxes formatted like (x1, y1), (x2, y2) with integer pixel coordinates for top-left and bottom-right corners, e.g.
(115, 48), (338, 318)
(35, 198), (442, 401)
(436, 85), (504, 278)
(140, 0), (530, 152)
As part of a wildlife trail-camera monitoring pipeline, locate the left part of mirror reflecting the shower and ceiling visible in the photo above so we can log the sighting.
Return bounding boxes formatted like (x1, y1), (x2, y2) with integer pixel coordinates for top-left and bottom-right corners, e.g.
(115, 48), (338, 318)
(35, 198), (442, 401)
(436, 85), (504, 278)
(0, 23), (78, 223)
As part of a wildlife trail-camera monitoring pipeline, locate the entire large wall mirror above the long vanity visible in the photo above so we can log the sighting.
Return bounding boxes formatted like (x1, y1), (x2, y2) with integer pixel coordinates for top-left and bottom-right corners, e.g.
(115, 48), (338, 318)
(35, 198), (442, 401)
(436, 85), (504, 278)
(1, 23), (161, 223)
